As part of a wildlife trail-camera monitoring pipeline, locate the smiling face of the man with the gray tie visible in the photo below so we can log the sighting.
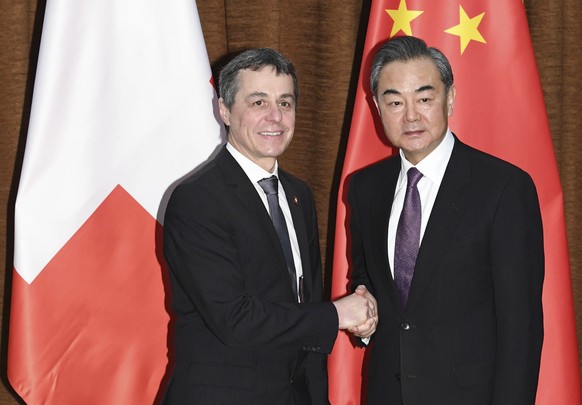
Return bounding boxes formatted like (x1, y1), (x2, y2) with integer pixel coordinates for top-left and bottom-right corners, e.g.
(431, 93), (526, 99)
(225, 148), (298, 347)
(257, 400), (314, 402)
(219, 66), (295, 172)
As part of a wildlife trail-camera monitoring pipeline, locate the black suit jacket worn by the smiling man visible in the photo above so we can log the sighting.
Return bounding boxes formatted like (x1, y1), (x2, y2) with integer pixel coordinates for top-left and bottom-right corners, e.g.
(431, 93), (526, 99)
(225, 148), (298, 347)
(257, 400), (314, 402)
(164, 148), (338, 405)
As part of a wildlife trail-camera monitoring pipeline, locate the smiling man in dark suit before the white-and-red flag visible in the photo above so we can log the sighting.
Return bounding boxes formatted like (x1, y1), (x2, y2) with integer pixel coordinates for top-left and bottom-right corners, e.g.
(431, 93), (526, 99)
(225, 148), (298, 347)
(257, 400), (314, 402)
(164, 49), (377, 405)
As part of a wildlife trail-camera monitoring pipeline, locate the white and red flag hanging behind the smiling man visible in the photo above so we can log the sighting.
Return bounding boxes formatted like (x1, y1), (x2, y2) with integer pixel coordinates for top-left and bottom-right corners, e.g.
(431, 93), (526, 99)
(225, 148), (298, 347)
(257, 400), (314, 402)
(8, 0), (222, 405)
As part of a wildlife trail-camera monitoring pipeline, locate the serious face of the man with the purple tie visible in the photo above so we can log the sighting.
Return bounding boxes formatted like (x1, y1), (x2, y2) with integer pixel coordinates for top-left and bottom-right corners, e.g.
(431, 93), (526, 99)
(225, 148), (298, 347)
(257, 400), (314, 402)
(374, 58), (456, 165)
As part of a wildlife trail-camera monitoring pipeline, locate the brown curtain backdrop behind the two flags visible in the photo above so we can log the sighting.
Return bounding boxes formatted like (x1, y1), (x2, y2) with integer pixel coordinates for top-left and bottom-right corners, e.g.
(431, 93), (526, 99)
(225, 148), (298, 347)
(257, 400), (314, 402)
(0, 0), (582, 404)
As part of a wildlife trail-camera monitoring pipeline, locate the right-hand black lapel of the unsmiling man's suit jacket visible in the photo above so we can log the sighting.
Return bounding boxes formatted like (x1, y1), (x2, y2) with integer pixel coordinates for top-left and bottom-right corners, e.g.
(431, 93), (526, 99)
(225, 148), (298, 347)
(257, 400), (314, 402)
(406, 139), (471, 311)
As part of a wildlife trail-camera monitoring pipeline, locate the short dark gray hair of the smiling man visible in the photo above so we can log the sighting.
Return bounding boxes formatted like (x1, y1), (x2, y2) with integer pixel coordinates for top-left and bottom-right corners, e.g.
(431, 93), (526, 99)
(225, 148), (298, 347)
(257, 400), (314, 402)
(218, 48), (299, 111)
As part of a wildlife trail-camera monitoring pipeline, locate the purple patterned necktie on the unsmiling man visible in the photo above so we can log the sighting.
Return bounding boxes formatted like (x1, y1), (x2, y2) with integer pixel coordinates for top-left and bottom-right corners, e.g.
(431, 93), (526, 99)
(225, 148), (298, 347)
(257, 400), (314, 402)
(394, 167), (422, 309)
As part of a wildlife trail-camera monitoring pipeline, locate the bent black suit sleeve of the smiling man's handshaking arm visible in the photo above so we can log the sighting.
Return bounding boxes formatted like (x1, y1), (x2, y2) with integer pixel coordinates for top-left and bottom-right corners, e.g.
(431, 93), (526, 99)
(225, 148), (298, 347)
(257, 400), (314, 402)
(164, 178), (338, 353)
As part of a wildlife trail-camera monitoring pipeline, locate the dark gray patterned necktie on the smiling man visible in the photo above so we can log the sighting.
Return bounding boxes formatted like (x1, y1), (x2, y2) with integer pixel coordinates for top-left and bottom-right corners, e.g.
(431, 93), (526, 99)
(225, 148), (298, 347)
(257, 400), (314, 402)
(259, 176), (297, 297)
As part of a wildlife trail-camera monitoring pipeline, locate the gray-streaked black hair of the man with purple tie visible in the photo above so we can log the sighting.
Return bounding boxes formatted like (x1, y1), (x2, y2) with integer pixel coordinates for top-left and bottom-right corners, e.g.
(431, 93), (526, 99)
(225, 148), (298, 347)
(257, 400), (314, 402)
(370, 36), (453, 97)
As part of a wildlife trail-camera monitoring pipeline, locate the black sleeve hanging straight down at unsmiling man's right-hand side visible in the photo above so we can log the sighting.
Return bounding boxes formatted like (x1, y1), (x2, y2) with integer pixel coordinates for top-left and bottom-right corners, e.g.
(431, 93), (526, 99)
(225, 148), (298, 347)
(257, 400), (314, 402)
(490, 172), (544, 404)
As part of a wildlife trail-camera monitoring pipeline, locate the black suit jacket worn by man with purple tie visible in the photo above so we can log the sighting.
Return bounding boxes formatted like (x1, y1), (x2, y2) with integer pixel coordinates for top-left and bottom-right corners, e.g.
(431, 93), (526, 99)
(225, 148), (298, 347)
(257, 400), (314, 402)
(349, 139), (544, 405)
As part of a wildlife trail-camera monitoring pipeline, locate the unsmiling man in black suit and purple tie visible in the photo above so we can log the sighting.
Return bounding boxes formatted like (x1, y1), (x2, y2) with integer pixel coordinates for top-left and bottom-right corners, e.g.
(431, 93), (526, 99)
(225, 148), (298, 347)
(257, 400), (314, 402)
(349, 37), (544, 405)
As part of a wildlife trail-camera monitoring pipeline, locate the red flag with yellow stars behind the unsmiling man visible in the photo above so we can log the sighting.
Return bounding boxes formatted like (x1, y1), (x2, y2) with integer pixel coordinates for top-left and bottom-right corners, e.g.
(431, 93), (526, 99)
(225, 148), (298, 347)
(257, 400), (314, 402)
(329, 0), (580, 405)
